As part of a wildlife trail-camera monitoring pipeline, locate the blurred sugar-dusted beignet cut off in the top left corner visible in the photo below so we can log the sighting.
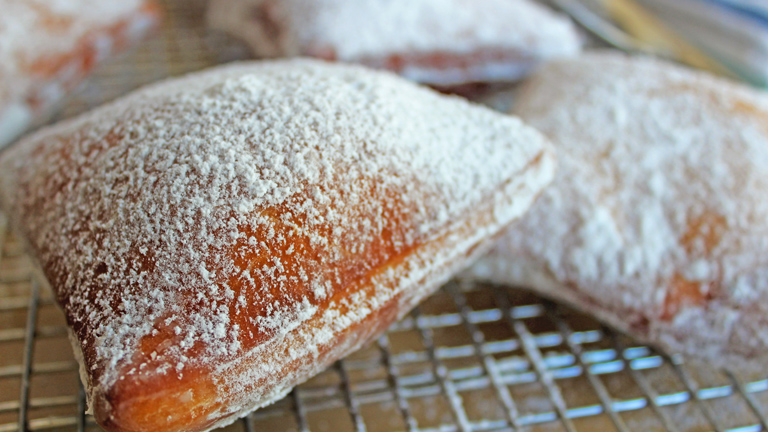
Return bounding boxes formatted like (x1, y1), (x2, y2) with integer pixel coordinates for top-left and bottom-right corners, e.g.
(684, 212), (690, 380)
(0, 0), (160, 147)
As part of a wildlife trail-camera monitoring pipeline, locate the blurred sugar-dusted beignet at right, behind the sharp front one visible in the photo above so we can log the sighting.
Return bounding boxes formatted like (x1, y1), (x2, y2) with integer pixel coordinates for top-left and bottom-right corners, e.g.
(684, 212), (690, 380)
(472, 53), (768, 367)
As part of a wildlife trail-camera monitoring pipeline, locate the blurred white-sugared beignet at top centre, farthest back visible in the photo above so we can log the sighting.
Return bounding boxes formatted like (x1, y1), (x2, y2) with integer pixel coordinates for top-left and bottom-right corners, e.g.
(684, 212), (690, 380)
(208, 0), (581, 87)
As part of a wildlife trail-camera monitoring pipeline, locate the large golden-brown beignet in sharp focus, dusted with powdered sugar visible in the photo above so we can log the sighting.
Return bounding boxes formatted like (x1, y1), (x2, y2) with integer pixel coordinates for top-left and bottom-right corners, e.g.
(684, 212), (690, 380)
(0, 60), (554, 431)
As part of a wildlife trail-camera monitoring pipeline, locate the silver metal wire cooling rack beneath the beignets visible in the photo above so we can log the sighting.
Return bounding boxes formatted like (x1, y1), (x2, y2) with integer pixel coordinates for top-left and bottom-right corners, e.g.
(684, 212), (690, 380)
(0, 0), (768, 432)
